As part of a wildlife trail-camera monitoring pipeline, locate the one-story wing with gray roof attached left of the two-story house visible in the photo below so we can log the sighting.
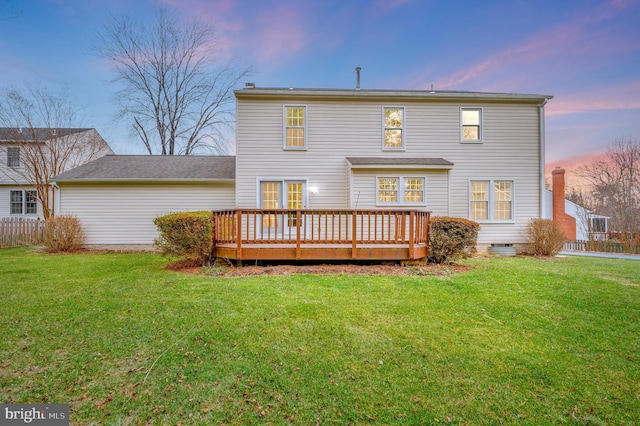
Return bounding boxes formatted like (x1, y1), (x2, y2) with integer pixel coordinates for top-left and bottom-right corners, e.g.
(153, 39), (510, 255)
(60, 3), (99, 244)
(55, 155), (235, 248)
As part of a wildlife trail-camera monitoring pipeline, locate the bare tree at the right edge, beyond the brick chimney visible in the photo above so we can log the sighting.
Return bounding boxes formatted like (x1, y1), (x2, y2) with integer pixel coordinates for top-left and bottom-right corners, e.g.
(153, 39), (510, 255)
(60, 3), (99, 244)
(579, 138), (640, 242)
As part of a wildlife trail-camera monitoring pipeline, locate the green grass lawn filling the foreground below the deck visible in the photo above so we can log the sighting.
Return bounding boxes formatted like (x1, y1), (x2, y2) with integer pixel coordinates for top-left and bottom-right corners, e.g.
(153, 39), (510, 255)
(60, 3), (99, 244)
(0, 249), (640, 425)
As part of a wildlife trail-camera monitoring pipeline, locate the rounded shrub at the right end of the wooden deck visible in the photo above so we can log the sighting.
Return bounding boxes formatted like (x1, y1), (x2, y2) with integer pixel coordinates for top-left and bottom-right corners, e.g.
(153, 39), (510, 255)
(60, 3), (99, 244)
(427, 217), (480, 263)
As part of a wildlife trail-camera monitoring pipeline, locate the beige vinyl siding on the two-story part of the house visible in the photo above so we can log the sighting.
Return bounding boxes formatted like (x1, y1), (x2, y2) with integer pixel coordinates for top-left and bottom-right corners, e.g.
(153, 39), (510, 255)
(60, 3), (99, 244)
(236, 98), (540, 245)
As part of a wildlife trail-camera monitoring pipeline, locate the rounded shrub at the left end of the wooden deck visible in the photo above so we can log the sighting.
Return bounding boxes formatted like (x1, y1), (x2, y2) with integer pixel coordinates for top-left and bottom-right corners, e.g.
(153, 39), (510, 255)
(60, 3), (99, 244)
(153, 211), (213, 266)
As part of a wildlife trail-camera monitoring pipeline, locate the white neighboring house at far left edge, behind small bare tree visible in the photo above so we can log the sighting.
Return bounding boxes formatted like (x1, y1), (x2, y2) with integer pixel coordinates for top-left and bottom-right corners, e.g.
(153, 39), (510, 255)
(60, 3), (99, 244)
(0, 127), (113, 219)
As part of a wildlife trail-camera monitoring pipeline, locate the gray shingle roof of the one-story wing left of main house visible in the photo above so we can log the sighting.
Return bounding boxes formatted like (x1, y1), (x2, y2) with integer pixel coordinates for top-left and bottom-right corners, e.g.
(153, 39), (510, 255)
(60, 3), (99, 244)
(52, 155), (236, 182)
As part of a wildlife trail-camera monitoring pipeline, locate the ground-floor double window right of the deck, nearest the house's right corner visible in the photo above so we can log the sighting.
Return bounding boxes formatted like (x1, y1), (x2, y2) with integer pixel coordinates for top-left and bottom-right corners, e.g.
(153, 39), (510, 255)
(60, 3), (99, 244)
(469, 180), (514, 222)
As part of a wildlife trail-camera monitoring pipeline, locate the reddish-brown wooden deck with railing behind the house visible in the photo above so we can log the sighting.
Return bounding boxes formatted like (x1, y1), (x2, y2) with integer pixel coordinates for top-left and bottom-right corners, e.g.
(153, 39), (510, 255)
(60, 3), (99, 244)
(213, 209), (430, 260)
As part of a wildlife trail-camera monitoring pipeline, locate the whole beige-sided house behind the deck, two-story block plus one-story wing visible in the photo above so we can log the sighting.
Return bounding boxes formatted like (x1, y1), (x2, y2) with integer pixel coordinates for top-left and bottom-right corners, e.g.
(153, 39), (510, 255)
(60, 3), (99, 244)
(56, 84), (552, 253)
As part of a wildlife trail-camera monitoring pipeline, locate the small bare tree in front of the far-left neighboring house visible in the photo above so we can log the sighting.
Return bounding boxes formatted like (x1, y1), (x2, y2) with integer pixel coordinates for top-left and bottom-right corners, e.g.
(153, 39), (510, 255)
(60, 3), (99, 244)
(0, 86), (113, 219)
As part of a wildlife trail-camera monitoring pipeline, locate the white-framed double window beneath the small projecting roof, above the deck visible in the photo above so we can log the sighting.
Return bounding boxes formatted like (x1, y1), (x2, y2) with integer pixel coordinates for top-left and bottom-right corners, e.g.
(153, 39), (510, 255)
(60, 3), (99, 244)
(376, 176), (426, 206)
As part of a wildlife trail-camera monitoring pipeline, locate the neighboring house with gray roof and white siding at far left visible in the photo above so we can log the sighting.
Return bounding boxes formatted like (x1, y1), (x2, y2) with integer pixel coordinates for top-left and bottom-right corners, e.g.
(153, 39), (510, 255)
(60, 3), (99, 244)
(0, 127), (113, 219)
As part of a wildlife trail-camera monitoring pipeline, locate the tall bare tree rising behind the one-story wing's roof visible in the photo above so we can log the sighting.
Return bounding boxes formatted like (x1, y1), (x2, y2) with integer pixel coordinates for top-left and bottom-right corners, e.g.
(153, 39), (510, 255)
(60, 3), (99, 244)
(95, 7), (249, 155)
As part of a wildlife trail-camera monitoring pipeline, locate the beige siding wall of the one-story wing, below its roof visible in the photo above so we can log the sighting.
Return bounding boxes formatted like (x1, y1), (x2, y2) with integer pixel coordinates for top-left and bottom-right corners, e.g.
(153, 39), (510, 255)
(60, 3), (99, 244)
(59, 183), (235, 245)
